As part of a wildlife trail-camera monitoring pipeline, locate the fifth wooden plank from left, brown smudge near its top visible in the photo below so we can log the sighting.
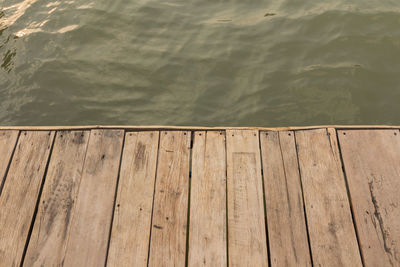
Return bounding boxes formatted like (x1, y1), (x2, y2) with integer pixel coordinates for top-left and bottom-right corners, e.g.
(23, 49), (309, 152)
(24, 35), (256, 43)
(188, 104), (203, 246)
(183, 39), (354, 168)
(107, 132), (159, 266)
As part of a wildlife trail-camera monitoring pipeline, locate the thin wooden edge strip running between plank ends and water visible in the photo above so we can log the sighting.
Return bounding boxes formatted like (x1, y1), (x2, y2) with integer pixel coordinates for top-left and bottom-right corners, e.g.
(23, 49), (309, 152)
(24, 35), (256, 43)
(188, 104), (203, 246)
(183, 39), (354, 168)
(0, 125), (400, 131)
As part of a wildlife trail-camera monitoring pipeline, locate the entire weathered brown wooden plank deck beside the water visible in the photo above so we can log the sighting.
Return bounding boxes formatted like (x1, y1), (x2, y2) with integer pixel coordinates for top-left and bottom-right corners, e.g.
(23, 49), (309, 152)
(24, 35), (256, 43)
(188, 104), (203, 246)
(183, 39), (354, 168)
(0, 127), (400, 267)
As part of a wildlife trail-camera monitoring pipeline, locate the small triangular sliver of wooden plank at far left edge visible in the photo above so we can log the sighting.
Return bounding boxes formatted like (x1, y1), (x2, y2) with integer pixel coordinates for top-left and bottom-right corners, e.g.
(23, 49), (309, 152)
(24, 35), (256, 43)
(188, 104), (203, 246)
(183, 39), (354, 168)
(0, 130), (19, 194)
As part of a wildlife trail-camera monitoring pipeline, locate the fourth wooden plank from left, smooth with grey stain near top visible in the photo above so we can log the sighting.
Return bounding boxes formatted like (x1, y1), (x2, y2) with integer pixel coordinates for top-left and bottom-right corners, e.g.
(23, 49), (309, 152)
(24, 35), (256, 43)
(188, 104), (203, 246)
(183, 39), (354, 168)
(63, 130), (124, 266)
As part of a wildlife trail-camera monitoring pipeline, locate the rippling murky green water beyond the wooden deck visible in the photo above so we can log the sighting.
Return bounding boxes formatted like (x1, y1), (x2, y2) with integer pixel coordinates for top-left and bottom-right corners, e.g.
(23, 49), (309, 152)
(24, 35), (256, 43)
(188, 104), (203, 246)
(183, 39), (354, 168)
(0, 0), (400, 126)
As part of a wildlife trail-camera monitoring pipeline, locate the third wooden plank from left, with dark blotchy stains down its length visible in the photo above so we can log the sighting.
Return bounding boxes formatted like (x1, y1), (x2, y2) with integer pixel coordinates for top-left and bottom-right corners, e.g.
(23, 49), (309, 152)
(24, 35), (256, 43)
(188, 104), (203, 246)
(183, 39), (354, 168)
(24, 131), (90, 266)
